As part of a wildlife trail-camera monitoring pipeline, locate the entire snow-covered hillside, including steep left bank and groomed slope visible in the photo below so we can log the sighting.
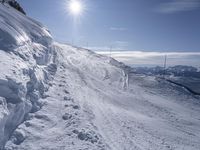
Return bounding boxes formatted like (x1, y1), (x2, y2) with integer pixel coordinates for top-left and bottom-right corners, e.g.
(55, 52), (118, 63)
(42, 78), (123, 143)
(0, 1), (200, 150)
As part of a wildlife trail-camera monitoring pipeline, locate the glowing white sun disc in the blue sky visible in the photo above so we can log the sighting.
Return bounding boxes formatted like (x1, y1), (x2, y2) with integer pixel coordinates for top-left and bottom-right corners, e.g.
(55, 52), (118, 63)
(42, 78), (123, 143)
(68, 0), (83, 16)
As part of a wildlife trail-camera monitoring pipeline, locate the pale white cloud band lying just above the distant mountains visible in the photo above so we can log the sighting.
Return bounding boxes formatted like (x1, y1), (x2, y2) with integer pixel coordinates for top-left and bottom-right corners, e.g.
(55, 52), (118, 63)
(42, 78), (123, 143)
(97, 51), (200, 67)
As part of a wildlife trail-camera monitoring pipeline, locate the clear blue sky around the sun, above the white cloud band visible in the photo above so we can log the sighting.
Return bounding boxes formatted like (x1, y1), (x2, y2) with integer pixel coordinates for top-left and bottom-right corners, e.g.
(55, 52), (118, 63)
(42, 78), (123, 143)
(18, 0), (200, 52)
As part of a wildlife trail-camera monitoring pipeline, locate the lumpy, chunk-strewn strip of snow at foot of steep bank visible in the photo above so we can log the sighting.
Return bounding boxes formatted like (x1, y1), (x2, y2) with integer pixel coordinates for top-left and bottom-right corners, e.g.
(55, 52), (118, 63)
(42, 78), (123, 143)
(6, 55), (108, 150)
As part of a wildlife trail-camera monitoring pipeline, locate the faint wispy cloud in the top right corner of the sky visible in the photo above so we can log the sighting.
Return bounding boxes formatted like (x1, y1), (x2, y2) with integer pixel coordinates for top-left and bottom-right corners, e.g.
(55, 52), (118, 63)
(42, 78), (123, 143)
(157, 0), (200, 14)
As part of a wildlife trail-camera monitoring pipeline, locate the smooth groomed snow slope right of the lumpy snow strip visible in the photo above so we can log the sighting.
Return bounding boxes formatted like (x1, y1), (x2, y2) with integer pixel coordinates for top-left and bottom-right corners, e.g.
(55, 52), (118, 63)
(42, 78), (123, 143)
(53, 44), (200, 150)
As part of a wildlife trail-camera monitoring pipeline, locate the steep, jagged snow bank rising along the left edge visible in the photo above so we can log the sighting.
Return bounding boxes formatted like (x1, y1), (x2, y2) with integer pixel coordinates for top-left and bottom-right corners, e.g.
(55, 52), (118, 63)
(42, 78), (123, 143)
(0, 5), (56, 149)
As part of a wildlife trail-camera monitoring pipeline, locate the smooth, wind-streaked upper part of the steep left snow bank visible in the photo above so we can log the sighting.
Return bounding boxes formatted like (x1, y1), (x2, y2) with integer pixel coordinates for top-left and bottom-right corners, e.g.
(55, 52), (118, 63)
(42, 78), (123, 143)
(0, 4), (52, 51)
